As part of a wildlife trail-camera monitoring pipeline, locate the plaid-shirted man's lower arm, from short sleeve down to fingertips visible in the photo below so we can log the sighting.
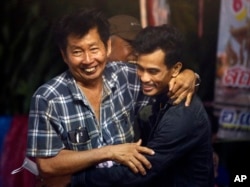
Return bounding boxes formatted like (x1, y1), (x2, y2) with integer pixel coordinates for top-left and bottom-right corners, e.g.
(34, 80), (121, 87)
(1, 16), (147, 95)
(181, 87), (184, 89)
(27, 89), (152, 177)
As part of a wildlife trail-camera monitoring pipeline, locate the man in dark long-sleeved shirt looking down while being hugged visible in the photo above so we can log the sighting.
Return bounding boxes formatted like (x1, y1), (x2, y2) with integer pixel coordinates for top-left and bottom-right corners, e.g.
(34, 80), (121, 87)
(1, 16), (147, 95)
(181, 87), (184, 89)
(72, 25), (213, 187)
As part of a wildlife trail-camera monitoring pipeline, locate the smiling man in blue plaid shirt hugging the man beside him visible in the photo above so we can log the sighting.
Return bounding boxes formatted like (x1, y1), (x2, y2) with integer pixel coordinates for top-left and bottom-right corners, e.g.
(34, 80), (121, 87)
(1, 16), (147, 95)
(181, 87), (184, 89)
(26, 9), (196, 187)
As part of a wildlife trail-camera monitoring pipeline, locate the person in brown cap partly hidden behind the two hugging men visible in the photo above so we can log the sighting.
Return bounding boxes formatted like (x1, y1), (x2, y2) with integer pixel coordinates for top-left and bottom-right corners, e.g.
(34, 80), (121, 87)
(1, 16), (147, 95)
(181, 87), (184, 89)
(109, 14), (142, 63)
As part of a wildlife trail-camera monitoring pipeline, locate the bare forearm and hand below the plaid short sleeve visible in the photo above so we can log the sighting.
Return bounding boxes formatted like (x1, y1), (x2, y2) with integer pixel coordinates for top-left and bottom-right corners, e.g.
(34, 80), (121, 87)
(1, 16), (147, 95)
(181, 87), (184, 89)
(36, 140), (154, 178)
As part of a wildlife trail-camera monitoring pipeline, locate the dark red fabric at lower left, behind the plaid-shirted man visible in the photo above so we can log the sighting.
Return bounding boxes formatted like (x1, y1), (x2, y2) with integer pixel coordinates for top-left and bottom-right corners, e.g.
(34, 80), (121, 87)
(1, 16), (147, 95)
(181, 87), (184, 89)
(0, 116), (36, 187)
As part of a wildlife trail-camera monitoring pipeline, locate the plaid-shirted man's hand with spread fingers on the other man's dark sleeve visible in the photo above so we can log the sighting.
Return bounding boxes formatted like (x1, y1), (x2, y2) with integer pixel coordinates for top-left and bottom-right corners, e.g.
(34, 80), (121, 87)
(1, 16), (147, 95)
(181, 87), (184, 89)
(109, 140), (154, 175)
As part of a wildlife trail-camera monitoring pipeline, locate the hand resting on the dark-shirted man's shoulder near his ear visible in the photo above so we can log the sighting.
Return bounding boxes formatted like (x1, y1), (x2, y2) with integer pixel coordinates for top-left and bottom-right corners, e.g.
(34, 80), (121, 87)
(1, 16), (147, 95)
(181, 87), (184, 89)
(168, 69), (197, 106)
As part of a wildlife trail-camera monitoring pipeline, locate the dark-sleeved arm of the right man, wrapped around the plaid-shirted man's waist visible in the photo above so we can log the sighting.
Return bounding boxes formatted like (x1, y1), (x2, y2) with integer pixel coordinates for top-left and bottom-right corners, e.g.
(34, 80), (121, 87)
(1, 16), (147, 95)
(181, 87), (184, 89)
(72, 101), (203, 187)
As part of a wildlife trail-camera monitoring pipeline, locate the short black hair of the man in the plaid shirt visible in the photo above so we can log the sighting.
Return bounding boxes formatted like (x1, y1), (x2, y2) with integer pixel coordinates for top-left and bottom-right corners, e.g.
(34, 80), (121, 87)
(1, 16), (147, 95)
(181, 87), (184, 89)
(53, 8), (110, 51)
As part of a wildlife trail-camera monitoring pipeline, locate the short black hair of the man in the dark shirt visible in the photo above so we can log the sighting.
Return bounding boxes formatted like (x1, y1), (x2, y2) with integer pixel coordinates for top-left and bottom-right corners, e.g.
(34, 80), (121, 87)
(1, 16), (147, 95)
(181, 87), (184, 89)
(132, 24), (184, 68)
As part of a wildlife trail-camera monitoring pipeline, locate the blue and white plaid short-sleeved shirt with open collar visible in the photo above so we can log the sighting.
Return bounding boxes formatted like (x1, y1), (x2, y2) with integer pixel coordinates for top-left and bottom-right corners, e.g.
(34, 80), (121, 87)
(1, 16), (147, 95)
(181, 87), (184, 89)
(27, 63), (149, 157)
